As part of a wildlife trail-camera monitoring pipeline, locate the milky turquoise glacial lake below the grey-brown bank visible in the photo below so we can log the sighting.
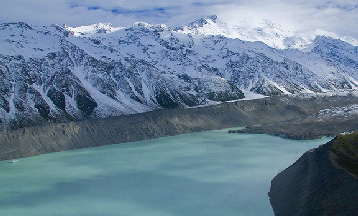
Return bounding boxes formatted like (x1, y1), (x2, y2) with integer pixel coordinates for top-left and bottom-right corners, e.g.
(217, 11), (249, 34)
(0, 129), (331, 216)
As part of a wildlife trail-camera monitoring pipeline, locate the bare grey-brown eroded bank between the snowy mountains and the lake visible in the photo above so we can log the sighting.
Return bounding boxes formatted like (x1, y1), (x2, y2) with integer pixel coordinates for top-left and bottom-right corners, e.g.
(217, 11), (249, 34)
(0, 94), (358, 160)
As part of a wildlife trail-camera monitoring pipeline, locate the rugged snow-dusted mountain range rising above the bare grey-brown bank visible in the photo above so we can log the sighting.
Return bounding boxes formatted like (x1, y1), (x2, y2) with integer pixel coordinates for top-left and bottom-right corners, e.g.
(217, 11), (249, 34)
(0, 16), (358, 128)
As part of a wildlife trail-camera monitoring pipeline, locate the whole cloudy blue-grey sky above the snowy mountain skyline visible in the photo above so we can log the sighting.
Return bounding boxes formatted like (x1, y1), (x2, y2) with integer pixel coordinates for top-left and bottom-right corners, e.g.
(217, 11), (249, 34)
(0, 0), (358, 39)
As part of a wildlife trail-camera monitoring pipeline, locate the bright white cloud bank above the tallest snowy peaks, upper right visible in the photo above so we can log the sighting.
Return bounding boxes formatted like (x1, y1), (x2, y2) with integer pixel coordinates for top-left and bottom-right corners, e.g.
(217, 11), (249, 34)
(211, 0), (358, 38)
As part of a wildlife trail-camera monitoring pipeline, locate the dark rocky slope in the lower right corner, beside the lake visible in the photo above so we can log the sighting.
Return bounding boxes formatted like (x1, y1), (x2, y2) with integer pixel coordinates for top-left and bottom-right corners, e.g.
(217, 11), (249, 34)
(269, 133), (358, 216)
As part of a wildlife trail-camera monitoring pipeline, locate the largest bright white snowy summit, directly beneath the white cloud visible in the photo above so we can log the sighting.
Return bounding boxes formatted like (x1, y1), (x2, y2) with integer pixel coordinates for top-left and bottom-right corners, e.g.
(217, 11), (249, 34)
(175, 15), (358, 51)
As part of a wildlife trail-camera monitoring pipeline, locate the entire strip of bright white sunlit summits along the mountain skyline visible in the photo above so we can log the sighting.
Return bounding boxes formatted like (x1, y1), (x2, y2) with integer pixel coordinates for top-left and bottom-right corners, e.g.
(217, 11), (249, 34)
(63, 15), (358, 51)
